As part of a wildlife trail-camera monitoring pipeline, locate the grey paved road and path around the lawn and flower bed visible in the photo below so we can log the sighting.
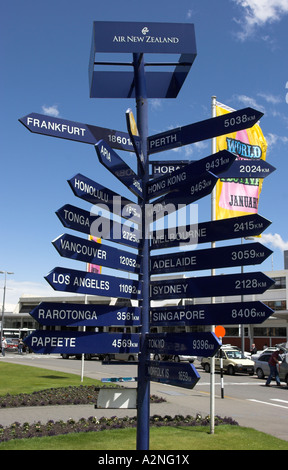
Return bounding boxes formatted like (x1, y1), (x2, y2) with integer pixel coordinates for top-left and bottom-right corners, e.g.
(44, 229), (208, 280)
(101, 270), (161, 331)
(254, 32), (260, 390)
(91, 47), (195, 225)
(0, 354), (288, 441)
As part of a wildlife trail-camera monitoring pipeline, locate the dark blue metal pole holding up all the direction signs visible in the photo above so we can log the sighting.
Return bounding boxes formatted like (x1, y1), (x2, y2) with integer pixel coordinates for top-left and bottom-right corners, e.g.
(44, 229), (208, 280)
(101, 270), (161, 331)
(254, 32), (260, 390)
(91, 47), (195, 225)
(133, 53), (150, 450)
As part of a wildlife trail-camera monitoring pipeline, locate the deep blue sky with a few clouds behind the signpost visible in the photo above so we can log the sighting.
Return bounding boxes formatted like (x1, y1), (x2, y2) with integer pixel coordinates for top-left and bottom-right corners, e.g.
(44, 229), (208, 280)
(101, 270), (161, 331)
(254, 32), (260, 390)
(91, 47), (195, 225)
(0, 0), (288, 310)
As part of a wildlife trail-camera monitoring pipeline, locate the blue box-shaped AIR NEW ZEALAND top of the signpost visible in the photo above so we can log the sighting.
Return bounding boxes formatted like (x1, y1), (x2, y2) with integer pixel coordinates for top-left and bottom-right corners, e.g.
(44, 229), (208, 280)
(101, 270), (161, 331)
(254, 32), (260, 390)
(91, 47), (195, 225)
(89, 21), (197, 98)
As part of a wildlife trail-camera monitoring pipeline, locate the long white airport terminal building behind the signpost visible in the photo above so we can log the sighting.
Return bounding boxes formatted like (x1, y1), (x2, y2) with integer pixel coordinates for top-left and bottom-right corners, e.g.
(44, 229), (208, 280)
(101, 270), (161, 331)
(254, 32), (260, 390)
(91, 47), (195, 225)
(3, 269), (288, 350)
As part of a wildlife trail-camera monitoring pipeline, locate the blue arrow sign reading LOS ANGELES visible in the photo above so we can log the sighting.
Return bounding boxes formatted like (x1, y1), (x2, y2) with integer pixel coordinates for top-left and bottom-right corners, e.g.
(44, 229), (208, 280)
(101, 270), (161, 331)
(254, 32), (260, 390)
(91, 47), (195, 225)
(45, 267), (142, 299)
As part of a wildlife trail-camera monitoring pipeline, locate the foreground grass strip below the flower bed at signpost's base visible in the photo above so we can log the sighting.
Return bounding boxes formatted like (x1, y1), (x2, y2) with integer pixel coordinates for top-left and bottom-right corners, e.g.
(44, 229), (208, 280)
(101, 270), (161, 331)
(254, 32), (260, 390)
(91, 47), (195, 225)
(0, 425), (288, 451)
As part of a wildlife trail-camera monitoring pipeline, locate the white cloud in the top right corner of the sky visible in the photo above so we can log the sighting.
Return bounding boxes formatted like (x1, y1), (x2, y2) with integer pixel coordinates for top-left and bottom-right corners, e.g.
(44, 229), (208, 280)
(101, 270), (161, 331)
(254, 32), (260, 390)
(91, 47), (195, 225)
(233, 0), (288, 41)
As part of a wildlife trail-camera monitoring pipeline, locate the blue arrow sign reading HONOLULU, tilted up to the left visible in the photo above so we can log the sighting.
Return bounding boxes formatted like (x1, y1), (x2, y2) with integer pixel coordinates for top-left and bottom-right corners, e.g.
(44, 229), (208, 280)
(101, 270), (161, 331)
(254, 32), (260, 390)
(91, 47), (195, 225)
(68, 173), (141, 222)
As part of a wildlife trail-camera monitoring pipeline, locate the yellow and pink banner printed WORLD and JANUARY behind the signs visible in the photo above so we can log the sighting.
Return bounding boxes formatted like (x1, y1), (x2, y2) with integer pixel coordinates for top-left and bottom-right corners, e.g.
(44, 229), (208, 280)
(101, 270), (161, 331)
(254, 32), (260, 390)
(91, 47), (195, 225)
(216, 103), (267, 220)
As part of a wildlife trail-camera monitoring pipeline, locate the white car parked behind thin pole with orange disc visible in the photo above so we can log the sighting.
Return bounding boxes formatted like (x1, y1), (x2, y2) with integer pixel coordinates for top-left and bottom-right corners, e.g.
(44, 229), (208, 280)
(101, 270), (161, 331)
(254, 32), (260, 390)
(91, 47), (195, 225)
(201, 346), (254, 375)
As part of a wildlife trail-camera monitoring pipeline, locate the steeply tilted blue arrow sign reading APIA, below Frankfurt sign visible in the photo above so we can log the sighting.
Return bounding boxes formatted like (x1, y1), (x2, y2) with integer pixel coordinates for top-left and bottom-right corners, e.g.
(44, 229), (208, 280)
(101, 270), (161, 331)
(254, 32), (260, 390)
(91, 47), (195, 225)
(95, 140), (143, 198)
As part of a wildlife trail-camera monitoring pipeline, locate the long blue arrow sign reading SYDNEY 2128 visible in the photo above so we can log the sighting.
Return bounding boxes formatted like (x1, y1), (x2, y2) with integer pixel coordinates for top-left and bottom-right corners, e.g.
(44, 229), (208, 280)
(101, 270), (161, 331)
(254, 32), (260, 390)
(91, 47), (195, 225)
(150, 272), (275, 300)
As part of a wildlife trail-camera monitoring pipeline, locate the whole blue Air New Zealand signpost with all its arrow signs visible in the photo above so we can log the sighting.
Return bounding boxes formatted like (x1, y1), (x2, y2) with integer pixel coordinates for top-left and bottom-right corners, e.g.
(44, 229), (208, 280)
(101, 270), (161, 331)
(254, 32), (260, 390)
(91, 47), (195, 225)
(20, 22), (274, 450)
